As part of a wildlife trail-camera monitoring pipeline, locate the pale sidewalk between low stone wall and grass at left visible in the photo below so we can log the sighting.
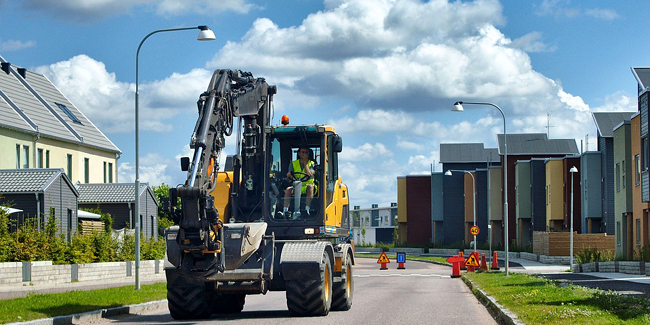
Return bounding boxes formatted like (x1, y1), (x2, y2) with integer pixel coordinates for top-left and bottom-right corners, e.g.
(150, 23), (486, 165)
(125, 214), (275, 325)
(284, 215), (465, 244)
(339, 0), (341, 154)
(0, 273), (166, 300)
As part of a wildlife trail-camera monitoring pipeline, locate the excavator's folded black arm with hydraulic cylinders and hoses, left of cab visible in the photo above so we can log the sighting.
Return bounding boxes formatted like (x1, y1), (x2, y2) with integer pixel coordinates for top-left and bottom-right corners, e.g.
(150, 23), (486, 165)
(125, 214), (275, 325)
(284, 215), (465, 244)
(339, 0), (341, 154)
(166, 70), (276, 271)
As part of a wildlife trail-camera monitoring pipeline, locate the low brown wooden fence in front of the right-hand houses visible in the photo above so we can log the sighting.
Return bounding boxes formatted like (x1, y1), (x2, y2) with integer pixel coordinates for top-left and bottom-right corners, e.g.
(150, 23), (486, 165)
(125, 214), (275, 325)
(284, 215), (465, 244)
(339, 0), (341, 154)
(533, 231), (616, 256)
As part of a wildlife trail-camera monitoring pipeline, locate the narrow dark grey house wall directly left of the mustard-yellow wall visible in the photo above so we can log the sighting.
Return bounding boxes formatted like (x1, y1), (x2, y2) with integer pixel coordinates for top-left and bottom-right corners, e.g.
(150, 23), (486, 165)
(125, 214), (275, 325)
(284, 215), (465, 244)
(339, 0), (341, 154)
(530, 158), (544, 231)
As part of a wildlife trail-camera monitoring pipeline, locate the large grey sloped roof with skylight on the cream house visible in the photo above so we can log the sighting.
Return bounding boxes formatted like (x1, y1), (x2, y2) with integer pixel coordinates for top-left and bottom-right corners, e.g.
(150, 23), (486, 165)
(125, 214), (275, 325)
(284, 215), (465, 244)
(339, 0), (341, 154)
(0, 56), (121, 153)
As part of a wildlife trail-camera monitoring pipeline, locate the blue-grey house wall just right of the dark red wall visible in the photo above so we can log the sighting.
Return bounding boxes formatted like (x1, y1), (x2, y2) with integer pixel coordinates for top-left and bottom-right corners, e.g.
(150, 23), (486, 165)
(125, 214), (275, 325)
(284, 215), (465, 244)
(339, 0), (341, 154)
(580, 151), (605, 234)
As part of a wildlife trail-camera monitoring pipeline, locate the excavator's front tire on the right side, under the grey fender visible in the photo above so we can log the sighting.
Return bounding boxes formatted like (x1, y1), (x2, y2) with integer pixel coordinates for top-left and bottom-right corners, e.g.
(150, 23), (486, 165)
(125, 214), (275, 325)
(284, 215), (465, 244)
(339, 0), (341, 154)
(286, 252), (332, 316)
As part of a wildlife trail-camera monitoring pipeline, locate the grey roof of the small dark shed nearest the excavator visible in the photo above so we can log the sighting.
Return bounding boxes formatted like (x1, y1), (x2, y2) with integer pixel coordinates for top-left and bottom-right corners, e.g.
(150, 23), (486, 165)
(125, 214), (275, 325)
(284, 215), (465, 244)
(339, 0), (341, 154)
(76, 183), (158, 204)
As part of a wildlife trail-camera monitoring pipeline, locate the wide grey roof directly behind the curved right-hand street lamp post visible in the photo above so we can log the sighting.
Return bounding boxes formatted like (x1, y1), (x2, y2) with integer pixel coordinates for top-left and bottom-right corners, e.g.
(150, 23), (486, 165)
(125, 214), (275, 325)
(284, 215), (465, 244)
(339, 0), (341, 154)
(497, 133), (579, 155)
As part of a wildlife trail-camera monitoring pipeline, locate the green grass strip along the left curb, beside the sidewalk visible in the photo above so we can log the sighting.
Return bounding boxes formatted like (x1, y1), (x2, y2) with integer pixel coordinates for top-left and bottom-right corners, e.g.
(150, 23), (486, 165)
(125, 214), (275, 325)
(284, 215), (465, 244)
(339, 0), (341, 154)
(0, 283), (167, 324)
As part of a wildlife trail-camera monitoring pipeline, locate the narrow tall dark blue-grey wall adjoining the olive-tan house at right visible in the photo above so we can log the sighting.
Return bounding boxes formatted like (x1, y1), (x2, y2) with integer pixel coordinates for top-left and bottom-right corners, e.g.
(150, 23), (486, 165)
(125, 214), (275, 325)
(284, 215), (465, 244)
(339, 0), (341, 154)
(598, 136), (614, 235)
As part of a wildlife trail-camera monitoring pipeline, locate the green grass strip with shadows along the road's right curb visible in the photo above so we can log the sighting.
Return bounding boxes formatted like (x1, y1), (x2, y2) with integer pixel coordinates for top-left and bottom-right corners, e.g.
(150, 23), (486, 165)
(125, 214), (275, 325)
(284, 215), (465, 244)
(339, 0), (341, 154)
(466, 272), (650, 325)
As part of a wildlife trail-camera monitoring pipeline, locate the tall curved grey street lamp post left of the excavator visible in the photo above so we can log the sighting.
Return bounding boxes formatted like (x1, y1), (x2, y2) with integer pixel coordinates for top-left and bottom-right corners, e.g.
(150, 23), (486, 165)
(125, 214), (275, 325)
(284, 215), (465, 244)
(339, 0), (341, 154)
(133, 26), (216, 290)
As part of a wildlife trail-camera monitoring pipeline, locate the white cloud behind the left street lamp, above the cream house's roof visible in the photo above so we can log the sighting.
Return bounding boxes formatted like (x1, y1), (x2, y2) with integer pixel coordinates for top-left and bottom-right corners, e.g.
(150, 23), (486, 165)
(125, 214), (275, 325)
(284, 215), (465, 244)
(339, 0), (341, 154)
(35, 54), (211, 133)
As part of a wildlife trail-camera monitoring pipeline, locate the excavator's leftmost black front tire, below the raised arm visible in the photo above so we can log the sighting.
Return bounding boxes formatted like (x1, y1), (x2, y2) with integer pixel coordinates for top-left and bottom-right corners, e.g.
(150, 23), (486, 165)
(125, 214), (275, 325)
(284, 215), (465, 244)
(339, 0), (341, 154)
(167, 271), (214, 320)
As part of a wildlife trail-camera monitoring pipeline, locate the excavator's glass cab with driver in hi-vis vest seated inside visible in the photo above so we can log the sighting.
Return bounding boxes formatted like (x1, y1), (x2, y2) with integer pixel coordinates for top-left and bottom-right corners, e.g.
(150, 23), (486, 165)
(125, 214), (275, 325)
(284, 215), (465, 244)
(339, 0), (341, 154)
(265, 125), (349, 238)
